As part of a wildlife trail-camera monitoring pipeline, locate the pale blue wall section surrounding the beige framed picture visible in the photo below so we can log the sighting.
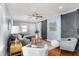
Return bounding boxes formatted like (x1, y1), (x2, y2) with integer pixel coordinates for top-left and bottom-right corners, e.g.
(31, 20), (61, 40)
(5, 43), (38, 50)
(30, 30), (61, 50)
(47, 16), (61, 41)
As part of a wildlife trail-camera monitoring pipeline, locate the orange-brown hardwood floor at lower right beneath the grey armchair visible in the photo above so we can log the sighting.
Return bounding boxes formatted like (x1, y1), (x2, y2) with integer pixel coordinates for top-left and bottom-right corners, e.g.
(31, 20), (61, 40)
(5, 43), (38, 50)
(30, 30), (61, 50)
(48, 48), (79, 56)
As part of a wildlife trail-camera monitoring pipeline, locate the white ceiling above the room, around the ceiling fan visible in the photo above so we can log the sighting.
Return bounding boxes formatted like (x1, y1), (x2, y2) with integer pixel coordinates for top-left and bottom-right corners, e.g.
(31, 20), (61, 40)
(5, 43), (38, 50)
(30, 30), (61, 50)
(7, 3), (79, 20)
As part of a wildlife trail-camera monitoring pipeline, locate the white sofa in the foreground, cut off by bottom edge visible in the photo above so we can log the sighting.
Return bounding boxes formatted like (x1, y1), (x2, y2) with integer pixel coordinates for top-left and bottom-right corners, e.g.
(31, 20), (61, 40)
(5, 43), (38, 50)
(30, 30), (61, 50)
(22, 46), (48, 56)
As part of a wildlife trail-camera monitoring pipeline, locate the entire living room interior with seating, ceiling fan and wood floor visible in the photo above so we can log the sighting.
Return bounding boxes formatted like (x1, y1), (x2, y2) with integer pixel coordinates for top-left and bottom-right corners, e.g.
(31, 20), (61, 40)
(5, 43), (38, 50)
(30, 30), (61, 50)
(0, 3), (79, 56)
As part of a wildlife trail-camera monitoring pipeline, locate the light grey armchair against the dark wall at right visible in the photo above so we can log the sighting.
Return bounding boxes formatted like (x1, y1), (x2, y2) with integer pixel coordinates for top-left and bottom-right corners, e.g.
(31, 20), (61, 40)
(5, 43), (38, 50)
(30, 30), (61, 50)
(60, 38), (77, 51)
